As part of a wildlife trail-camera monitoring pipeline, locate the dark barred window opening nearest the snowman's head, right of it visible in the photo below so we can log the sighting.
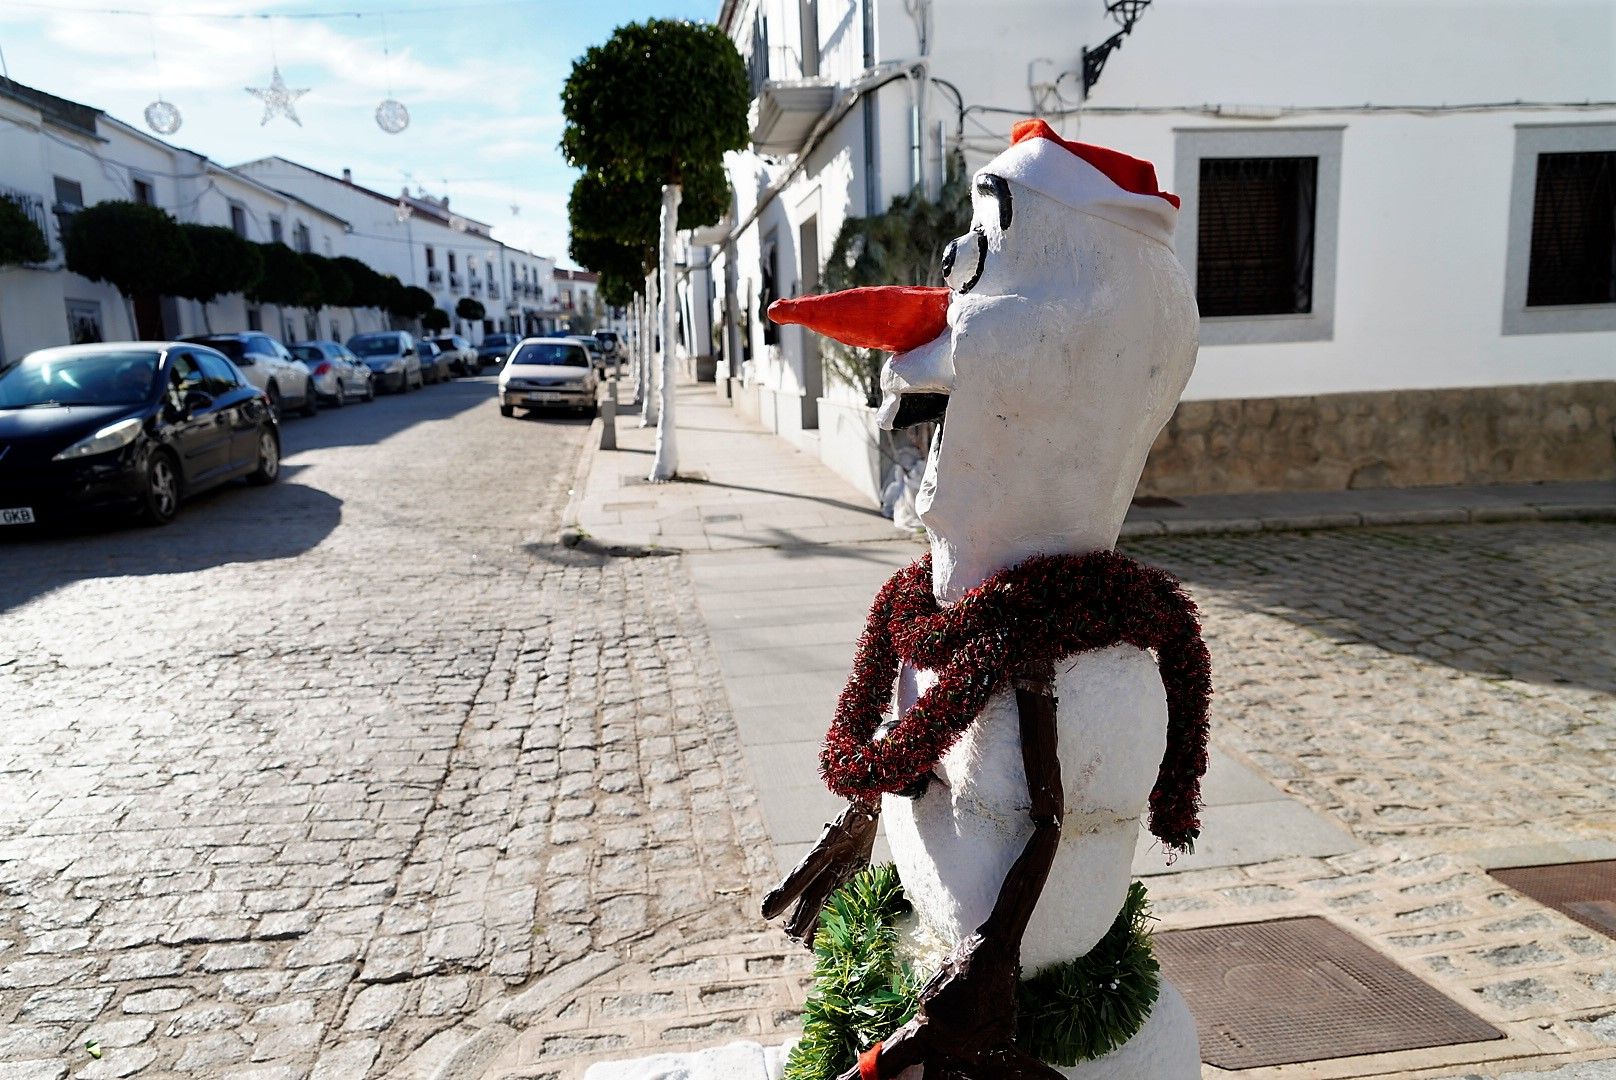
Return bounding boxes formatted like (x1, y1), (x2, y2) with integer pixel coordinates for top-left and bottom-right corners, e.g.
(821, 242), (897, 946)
(1196, 157), (1319, 315)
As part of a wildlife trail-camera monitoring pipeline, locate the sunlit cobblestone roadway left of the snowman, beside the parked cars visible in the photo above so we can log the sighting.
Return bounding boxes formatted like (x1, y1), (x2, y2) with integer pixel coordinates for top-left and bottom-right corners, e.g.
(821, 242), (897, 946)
(0, 380), (795, 1080)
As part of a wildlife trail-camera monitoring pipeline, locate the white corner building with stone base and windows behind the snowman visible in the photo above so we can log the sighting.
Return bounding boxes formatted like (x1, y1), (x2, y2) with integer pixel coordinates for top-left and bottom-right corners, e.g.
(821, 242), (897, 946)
(713, 0), (1616, 495)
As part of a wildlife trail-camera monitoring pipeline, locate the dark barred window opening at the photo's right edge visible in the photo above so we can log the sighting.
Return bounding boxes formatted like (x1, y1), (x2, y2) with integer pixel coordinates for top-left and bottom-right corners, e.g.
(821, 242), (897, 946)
(1526, 150), (1616, 307)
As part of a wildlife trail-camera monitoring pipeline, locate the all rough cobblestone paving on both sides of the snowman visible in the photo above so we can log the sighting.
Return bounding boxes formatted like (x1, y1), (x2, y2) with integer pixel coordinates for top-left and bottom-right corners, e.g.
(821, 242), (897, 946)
(0, 380), (1616, 1080)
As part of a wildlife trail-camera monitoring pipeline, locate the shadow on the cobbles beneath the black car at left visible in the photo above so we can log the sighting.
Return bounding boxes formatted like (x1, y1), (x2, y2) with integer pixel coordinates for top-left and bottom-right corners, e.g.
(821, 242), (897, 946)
(0, 466), (343, 611)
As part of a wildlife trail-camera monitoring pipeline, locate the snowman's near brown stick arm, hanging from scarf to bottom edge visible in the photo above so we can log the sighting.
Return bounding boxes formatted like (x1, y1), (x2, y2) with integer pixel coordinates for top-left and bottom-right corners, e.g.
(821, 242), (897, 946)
(840, 668), (1065, 1080)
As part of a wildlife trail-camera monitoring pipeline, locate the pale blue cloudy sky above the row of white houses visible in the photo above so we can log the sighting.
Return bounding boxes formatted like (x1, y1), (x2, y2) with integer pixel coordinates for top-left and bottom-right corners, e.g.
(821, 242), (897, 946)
(0, 0), (719, 265)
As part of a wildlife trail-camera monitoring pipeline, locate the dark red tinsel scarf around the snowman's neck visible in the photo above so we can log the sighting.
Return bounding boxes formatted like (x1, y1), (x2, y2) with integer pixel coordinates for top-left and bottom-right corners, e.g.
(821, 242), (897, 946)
(819, 551), (1212, 850)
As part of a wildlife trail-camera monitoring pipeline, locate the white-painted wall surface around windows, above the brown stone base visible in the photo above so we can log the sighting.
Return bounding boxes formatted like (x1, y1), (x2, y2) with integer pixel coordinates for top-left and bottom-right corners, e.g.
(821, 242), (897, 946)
(730, 0), (1616, 413)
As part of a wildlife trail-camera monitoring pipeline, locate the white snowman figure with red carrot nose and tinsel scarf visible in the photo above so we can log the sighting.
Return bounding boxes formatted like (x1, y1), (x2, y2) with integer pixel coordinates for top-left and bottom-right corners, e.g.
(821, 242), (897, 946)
(764, 121), (1210, 1080)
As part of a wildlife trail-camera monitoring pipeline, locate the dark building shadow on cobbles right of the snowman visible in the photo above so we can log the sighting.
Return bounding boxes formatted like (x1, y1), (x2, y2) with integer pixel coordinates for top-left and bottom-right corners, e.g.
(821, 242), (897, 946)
(1123, 522), (1616, 692)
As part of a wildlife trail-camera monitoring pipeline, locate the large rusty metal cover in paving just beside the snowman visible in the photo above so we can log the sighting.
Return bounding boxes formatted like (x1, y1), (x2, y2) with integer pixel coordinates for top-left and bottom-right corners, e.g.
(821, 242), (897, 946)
(1155, 918), (1503, 1069)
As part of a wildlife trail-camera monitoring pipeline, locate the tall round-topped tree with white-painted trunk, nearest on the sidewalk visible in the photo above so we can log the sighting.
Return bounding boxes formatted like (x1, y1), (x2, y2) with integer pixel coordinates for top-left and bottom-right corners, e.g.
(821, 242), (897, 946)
(561, 19), (751, 480)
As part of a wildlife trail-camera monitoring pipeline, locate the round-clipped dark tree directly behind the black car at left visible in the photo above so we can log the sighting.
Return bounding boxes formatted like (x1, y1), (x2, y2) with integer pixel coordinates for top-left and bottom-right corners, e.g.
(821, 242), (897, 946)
(66, 200), (191, 333)
